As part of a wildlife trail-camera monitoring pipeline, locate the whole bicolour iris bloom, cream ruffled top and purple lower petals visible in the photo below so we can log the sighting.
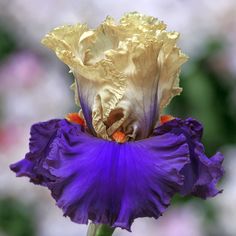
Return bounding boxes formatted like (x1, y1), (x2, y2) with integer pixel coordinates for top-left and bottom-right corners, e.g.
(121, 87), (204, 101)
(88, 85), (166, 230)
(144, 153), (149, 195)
(11, 12), (223, 234)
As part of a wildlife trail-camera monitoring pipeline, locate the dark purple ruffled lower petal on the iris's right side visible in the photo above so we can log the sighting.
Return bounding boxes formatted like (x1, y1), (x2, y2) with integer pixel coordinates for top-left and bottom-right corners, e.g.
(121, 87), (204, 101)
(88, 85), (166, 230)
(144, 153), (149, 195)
(154, 118), (224, 199)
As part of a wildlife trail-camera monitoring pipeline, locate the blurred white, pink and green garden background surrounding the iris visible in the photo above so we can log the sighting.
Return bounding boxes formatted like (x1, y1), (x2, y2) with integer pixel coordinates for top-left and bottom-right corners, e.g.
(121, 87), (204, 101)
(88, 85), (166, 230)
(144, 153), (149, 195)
(0, 0), (236, 236)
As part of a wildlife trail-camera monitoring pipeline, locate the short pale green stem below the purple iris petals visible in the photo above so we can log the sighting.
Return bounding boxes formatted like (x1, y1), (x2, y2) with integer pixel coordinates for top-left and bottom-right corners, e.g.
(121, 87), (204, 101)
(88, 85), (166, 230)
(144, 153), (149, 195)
(87, 223), (115, 236)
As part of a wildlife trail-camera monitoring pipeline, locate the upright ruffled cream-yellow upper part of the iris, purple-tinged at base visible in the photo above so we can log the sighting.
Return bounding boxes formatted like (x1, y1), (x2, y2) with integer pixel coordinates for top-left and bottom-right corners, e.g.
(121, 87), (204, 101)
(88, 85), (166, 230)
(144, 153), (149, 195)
(42, 13), (187, 140)
